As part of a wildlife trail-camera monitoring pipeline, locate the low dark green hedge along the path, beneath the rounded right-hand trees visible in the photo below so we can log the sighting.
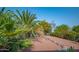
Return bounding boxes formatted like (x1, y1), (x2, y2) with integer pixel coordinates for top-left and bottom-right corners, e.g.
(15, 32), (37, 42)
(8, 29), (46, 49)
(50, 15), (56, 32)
(50, 31), (79, 42)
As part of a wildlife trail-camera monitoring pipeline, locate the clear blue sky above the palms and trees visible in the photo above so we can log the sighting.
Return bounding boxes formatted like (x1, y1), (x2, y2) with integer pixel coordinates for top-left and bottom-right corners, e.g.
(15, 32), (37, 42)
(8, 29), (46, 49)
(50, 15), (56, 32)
(0, 7), (79, 27)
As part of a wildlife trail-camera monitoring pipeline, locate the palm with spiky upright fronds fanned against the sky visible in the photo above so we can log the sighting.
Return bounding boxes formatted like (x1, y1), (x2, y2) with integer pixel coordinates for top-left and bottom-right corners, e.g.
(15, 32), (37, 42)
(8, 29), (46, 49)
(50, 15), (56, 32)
(14, 10), (38, 37)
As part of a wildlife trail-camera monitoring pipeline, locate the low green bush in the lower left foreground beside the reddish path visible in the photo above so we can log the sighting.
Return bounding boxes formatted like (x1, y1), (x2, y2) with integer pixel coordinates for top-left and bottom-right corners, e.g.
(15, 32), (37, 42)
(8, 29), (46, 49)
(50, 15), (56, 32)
(8, 39), (32, 52)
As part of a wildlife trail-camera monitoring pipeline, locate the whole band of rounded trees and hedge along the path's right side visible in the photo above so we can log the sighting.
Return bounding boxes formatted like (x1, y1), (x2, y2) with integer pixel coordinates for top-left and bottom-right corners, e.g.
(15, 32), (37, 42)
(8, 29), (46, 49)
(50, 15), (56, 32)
(51, 25), (79, 42)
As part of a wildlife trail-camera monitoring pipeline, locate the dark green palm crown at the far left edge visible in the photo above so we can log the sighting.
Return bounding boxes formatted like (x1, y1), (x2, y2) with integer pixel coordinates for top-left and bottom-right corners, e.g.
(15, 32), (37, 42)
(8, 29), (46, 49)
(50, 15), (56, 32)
(0, 8), (14, 31)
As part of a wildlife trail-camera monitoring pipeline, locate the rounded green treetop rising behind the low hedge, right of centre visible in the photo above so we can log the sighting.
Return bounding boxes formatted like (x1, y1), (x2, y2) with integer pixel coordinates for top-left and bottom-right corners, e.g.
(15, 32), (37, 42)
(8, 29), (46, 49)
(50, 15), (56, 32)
(53, 24), (69, 38)
